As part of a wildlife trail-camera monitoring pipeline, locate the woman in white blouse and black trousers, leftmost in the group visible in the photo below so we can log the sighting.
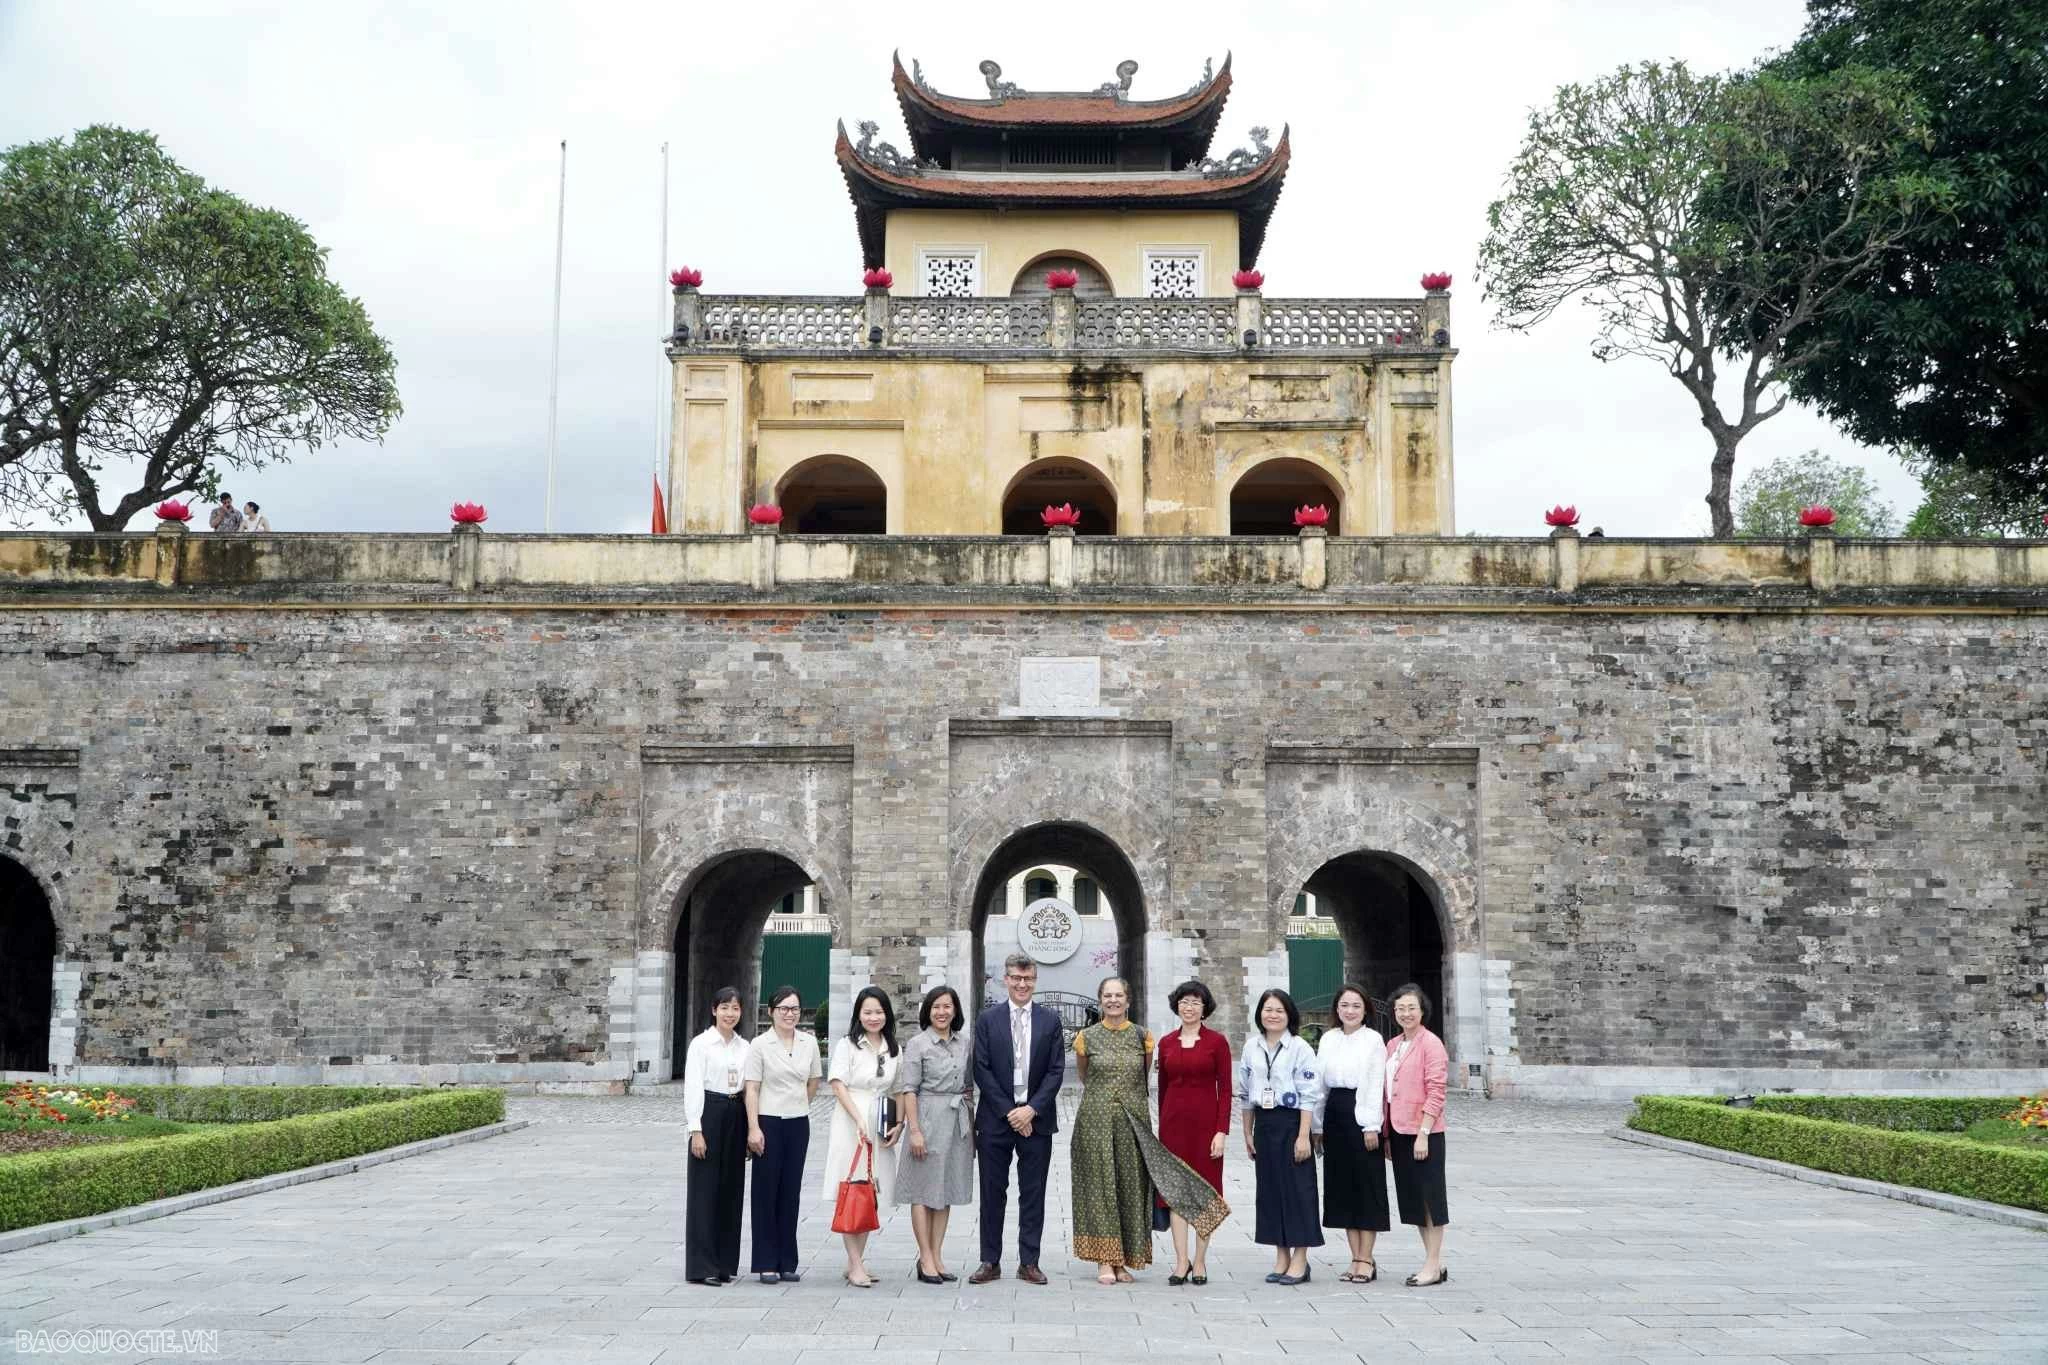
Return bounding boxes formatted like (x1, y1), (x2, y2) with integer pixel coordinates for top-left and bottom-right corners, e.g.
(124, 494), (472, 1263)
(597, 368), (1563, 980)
(682, 986), (748, 1285)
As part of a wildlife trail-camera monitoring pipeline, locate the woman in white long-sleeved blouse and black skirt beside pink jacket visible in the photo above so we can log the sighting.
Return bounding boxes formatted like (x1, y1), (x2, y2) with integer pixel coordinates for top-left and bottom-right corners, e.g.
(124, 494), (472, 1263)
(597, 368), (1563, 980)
(1310, 982), (1389, 1285)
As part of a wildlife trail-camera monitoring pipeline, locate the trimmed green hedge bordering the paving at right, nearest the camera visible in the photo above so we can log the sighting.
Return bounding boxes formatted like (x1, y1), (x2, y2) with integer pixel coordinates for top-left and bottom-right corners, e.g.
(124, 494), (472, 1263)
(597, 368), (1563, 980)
(1628, 1095), (2048, 1212)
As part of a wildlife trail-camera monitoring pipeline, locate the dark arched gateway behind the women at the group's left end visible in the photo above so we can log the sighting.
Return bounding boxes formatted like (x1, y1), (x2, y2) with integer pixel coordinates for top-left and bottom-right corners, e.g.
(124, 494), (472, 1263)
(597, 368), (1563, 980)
(670, 849), (829, 1076)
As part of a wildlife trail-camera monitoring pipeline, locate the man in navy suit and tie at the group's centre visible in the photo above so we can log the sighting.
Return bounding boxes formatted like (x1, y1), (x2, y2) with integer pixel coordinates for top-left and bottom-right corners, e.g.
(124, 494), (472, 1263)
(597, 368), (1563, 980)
(967, 954), (1067, 1285)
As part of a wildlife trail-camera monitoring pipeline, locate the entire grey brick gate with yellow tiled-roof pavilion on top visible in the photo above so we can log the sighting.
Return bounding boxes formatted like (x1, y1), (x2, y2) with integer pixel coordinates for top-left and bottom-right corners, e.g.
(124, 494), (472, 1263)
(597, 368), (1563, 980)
(0, 63), (2048, 1093)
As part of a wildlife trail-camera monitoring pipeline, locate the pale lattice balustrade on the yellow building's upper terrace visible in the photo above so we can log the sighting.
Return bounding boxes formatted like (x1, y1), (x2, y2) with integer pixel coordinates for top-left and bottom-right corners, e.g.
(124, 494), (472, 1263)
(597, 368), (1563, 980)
(670, 289), (1450, 358)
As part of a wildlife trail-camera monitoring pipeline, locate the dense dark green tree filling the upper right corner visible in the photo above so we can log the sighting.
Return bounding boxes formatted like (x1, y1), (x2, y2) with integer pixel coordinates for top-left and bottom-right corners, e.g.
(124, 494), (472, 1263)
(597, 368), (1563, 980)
(1769, 0), (2048, 493)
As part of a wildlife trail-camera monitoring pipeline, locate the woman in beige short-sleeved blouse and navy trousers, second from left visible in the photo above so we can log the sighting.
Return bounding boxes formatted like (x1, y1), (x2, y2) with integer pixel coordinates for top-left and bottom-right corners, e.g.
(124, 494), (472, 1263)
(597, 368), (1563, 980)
(743, 986), (823, 1285)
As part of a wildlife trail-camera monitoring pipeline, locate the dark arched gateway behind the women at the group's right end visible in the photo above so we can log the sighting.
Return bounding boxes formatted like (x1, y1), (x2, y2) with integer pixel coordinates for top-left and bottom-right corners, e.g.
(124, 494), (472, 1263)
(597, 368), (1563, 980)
(1290, 849), (1456, 1050)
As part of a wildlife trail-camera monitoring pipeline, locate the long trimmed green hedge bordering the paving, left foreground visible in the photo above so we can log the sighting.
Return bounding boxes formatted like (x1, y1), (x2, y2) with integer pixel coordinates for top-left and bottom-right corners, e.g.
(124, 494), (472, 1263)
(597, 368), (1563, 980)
(0, 1087), (506, 1232)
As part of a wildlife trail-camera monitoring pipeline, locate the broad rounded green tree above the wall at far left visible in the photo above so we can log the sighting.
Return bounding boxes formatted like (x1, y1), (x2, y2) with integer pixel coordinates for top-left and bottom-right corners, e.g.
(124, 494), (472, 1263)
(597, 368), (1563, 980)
(0, 127), (399, 530)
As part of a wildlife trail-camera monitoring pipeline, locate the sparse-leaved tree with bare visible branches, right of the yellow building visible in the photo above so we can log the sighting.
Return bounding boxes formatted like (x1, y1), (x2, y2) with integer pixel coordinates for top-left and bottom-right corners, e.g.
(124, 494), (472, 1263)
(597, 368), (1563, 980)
(1479, 63), (1944, 536)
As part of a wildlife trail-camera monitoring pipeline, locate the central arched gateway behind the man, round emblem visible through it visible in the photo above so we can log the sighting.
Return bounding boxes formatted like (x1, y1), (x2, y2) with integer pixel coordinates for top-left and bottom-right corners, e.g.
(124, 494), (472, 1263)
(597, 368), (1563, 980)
(969, 821), (1151, 1025)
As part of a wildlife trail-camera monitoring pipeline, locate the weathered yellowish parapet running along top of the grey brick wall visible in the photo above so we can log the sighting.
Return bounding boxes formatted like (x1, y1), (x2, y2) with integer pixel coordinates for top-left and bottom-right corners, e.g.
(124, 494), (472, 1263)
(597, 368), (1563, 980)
(0, 528), (2048, 612)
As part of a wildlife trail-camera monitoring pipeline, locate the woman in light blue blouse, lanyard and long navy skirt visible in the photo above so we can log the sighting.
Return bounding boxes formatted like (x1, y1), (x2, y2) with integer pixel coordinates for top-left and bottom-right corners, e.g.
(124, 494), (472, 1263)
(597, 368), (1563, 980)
(1237, 990), (1323, 1285)
